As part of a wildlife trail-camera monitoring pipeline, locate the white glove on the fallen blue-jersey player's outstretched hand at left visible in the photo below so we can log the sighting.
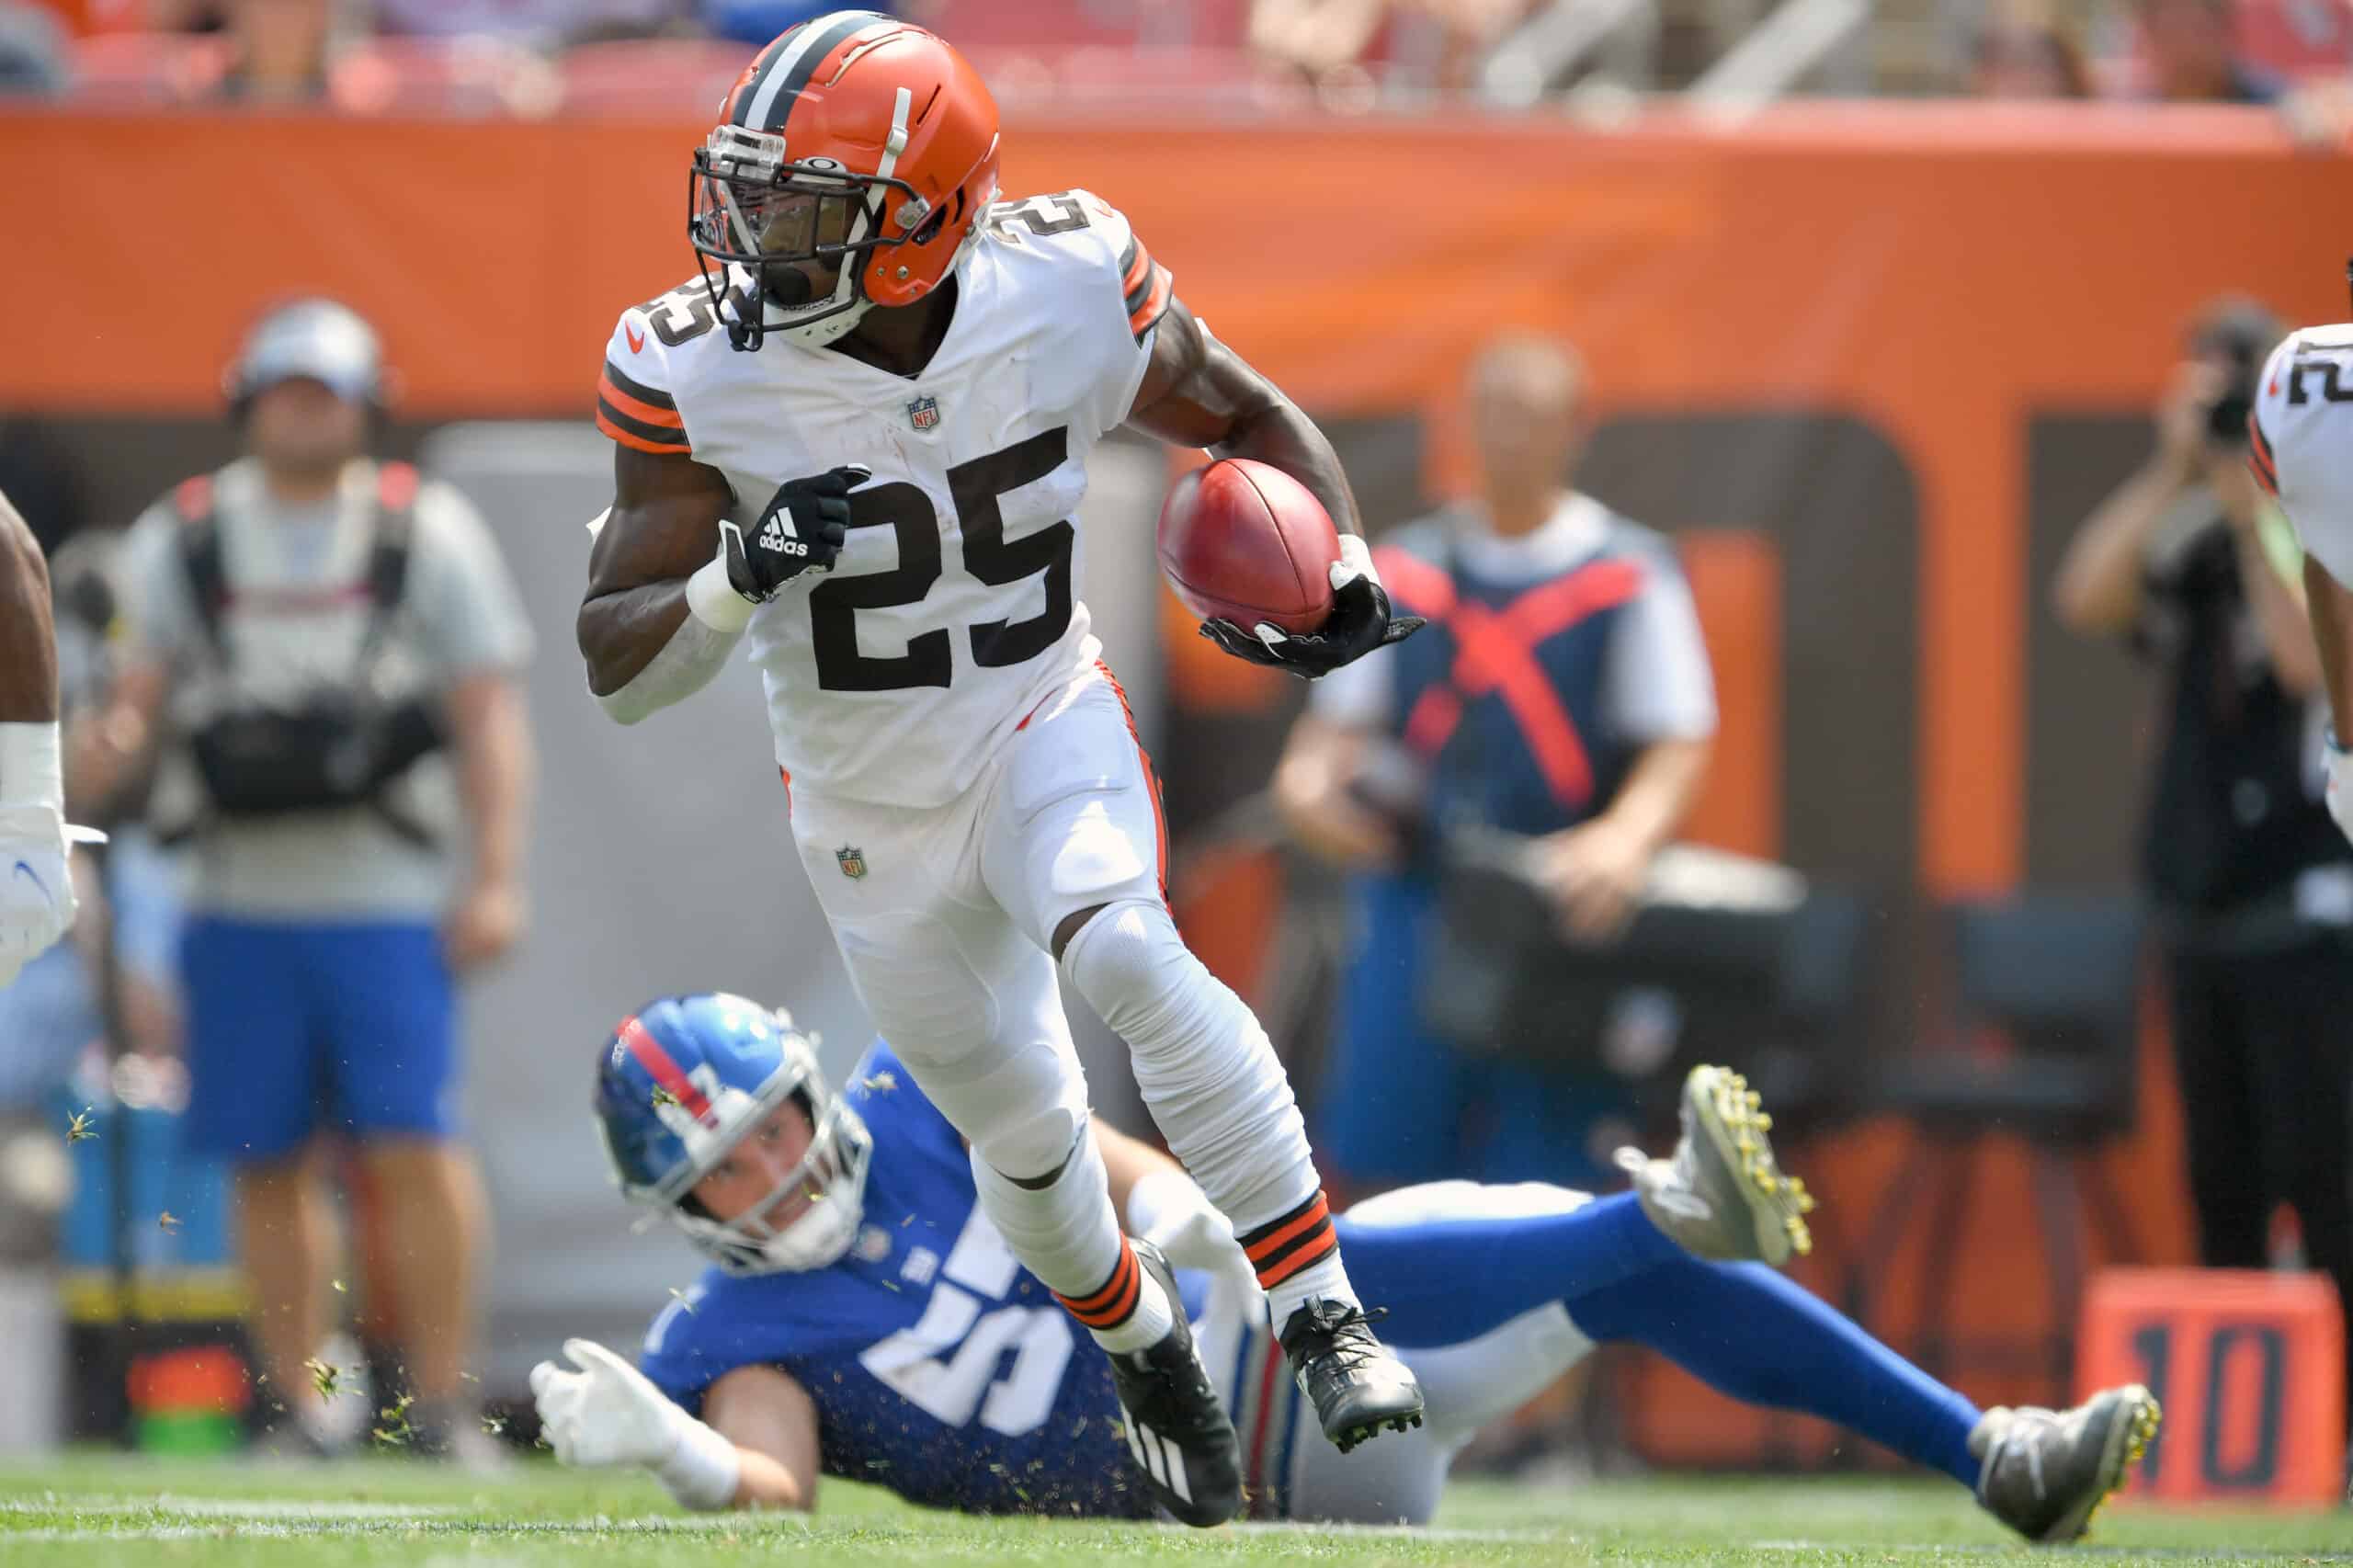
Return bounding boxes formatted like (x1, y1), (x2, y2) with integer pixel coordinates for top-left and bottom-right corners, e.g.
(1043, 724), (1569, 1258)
(532, 1340), (739, 1509)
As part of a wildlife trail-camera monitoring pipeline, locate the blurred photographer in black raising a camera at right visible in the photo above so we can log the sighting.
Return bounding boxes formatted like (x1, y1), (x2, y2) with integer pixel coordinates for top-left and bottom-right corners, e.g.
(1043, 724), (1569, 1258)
(2052, 299), (2353, 1403)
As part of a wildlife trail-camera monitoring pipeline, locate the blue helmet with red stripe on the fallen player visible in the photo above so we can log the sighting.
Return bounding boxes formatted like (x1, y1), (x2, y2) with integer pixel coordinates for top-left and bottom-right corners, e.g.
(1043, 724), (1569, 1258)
(596, 991), (873, 1274)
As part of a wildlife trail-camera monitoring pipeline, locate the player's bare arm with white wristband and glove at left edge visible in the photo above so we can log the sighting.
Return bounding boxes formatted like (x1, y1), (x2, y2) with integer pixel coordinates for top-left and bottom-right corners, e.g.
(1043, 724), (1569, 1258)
(0, 483), (101, 986)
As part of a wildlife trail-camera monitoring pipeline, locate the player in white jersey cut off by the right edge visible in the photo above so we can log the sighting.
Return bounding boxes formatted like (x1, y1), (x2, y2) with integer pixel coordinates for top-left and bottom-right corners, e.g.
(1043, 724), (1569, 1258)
(2247, 266), (2353, 838)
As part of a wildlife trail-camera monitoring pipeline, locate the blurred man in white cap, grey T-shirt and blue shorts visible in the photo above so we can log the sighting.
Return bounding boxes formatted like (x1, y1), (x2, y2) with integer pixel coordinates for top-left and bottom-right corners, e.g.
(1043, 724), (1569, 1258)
(68, 299), (532, 1458)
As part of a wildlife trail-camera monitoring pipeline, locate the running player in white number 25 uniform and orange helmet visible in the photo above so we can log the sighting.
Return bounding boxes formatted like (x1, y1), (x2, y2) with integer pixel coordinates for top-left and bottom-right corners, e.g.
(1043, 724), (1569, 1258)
(579, 12), (1421, 1523)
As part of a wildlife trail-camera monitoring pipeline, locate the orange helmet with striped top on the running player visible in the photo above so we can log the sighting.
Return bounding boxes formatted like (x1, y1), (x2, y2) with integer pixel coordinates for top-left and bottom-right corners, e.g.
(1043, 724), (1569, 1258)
(688, 12), (997, 348)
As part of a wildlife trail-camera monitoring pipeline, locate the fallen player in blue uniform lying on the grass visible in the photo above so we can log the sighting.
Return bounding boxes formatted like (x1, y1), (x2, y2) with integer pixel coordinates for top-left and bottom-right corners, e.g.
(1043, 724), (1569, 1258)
(532, 996), (2158, 1542)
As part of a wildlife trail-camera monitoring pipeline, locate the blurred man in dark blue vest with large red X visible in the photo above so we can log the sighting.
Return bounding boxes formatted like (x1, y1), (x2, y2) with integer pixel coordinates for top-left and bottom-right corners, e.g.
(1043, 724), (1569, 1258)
(1276, 335), (1715, 1187)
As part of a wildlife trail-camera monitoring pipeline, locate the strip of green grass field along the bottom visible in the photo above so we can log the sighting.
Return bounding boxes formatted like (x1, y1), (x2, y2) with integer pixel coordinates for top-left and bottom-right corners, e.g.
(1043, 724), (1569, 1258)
(0, 1455), (2353, 1568)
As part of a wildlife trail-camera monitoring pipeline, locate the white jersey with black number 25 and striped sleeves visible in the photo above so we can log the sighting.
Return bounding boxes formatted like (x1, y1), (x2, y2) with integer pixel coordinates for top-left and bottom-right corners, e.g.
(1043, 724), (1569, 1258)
(597, 190), (1169, 808)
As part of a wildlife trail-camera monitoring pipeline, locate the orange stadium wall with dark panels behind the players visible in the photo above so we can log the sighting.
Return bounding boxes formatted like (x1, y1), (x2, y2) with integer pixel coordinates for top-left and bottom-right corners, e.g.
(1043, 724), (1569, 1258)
(0, 106), (2353, 1458)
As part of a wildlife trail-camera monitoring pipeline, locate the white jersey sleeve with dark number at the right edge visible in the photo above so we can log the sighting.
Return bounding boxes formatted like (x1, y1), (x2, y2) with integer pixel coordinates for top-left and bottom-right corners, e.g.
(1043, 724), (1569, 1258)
(2247, 323), (2353, 586)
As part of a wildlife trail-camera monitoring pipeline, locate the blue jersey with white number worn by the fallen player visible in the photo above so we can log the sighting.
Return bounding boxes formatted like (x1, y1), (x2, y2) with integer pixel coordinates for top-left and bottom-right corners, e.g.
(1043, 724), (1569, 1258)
(642, 1043), (1162, 1518)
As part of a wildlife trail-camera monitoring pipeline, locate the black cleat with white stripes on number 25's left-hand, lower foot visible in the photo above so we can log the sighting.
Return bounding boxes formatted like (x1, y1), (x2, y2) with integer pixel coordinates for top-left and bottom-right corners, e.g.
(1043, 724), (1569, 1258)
(1104, 1241), (1251, 1528)
